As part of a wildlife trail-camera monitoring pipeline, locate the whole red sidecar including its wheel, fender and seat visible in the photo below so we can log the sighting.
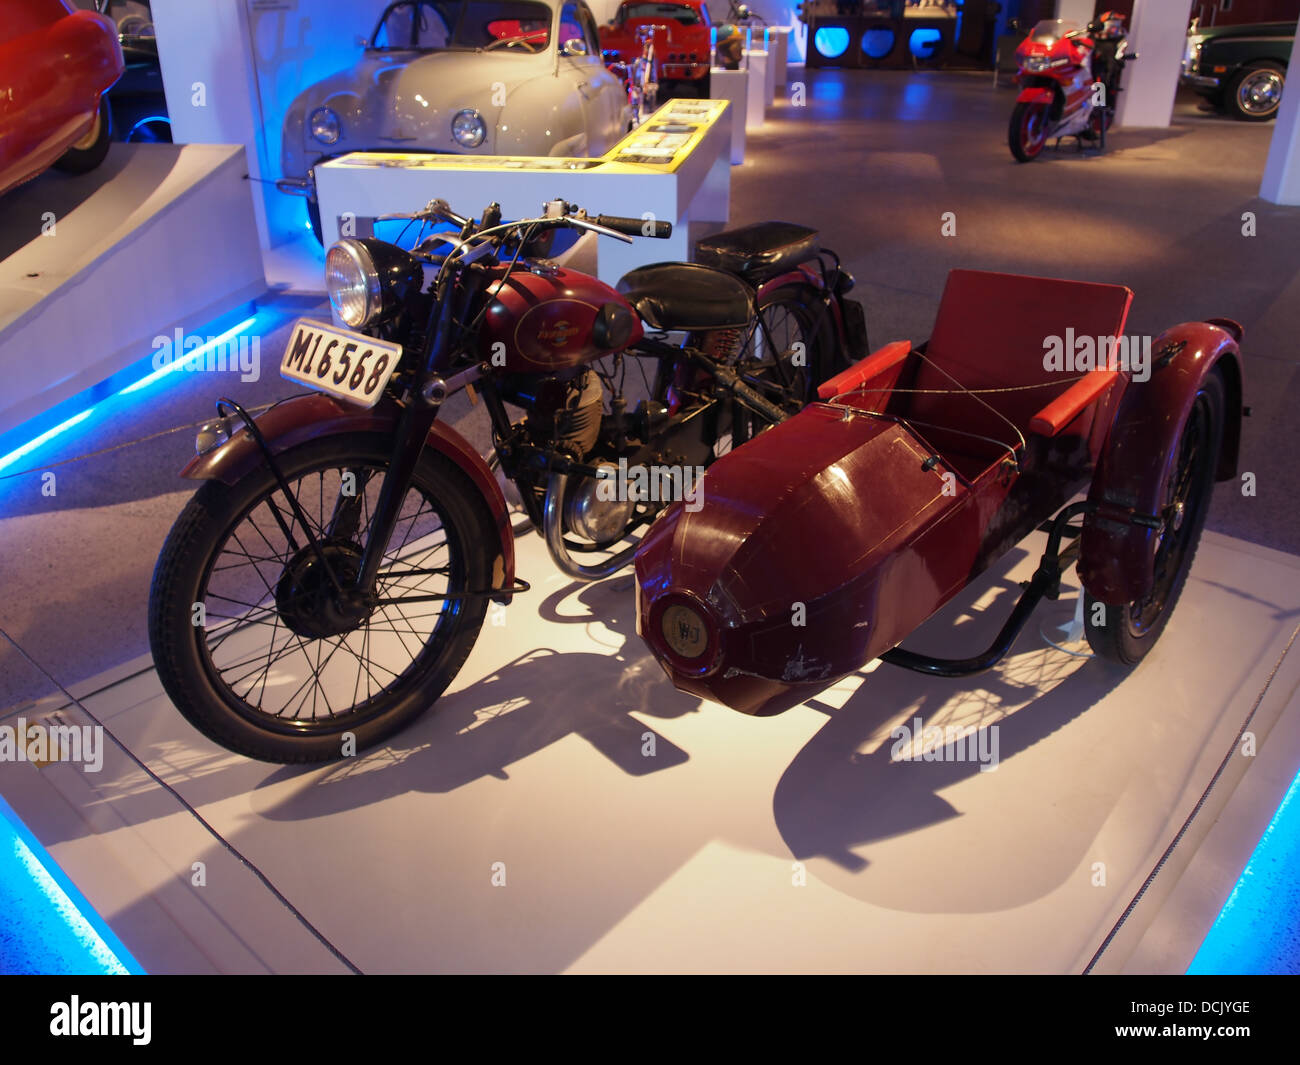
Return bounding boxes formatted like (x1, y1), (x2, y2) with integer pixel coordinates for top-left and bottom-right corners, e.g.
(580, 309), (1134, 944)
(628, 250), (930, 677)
(636, 270), (1242, 714)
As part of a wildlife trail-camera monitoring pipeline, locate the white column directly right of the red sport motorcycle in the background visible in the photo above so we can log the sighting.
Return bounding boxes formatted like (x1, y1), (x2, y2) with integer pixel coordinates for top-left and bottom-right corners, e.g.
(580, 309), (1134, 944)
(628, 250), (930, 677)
(1115, 0), (1192, 126)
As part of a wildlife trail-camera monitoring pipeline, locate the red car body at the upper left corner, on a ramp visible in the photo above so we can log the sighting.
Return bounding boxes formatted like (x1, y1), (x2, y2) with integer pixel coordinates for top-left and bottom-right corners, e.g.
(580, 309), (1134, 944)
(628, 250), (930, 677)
(0, 0), (125, 192)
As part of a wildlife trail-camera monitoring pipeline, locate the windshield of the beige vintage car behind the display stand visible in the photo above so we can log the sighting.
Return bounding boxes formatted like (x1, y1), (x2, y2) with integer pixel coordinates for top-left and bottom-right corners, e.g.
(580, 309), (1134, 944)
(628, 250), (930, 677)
(371, 0), (551, 52)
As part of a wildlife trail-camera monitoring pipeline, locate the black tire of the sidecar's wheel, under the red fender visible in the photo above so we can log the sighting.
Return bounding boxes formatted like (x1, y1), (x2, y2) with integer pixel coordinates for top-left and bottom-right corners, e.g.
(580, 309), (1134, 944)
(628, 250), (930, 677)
(1083, 371), (1226, 666)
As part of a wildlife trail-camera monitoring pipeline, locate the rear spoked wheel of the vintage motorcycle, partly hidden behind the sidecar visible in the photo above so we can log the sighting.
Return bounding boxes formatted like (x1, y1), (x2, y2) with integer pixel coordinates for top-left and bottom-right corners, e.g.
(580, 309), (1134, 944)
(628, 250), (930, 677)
(732, 285), (831, 447)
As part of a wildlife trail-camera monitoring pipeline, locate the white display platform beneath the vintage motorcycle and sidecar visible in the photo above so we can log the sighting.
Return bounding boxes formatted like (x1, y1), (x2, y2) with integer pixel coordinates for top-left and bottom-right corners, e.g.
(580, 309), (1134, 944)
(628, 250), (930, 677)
(0, 527), (1300, 973)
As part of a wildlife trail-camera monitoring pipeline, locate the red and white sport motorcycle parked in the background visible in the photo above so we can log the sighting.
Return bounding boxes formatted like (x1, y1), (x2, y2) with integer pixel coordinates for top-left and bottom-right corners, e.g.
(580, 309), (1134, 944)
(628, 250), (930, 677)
(1006, 12), (1138, 163)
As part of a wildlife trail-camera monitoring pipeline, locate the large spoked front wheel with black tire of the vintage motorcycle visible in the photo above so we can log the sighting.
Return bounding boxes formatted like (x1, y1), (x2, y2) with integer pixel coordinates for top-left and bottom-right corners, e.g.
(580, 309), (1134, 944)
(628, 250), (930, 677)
(150, 434), (497, 762)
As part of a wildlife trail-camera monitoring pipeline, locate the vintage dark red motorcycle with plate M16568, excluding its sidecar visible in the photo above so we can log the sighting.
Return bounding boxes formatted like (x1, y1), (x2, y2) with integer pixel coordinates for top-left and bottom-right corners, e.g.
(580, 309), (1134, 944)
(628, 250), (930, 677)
(150, 200), (866, 762)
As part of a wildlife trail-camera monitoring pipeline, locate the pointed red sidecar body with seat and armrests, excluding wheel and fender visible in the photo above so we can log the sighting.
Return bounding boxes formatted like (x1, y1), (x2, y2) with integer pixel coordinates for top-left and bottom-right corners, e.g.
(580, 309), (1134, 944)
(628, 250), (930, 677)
(636, 270), (1164, 714)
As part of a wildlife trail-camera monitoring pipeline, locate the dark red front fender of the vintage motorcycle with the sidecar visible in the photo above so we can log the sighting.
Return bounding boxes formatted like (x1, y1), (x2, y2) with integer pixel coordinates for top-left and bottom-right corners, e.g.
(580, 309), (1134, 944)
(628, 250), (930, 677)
(181, 393), (515, 602)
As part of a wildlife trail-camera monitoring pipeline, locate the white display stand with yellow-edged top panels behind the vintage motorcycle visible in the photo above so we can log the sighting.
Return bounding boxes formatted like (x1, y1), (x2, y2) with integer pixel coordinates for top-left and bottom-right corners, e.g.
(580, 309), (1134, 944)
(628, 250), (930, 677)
(316, 100), (732, 285)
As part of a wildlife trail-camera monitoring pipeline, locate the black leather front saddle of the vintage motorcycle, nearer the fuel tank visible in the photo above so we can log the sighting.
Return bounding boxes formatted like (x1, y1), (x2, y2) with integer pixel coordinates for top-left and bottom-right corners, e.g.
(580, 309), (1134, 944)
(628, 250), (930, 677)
(618, 263), (750, 332)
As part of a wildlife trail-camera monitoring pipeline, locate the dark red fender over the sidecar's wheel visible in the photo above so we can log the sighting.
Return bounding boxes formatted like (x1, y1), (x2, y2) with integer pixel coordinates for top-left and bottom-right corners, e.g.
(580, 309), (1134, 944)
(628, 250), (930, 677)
(1079, 319), (1242, 603)
